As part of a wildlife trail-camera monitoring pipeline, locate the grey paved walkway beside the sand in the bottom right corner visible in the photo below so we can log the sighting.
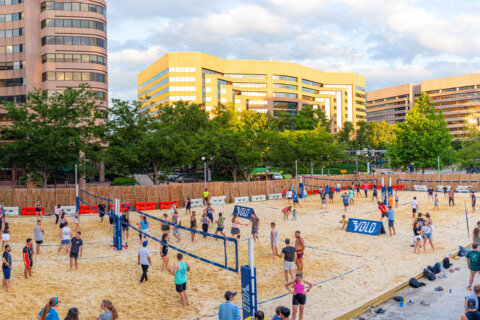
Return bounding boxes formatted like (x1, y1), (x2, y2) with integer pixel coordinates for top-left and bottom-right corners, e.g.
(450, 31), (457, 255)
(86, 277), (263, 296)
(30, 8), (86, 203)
(356, 257), (470, 320)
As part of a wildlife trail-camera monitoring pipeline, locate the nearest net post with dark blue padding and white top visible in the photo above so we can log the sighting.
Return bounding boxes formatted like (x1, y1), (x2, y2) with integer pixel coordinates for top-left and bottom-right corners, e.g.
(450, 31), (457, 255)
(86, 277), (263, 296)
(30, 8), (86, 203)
(241, 238), (257, 319)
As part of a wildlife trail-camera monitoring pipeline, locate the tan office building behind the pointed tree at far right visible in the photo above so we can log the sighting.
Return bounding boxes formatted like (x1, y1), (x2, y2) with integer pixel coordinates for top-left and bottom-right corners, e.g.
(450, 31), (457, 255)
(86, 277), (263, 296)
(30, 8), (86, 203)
(367, 73), (480, 138)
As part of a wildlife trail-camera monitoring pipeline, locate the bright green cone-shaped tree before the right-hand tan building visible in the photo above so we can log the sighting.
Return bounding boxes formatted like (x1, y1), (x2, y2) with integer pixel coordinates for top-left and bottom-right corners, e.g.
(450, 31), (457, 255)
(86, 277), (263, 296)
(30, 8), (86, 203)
(389, 93), (456, 171)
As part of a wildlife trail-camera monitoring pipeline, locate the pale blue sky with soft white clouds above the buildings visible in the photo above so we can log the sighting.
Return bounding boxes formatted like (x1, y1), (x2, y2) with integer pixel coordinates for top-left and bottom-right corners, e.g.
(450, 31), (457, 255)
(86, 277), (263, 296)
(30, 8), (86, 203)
(107, 0), (480, 100)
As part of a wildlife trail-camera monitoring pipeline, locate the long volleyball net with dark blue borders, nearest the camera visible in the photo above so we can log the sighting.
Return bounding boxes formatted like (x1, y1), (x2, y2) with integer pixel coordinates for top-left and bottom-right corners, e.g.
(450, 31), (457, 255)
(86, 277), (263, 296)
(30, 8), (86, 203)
(77, 189), (239, 272)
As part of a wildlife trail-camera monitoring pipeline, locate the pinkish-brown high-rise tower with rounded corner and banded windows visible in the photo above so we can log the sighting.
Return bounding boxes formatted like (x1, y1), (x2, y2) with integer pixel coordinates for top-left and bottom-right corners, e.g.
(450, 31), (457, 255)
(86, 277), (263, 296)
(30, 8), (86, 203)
(0, 0), (108, 181)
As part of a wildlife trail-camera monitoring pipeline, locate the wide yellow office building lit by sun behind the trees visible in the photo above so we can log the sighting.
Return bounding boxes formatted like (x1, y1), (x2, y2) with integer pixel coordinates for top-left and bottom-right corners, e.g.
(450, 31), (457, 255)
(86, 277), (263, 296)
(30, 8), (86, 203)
(137, 52), (366, 132)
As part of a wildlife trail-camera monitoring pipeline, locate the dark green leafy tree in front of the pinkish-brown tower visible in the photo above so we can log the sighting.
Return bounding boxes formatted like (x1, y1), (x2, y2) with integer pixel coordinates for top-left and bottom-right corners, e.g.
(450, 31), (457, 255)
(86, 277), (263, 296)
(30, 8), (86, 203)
(0, 85), (105, 186)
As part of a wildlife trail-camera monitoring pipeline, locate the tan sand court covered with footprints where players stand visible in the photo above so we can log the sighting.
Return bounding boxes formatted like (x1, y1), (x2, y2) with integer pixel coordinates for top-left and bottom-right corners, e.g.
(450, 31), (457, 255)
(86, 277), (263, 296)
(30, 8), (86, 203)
(0, 191), (480, 319)
